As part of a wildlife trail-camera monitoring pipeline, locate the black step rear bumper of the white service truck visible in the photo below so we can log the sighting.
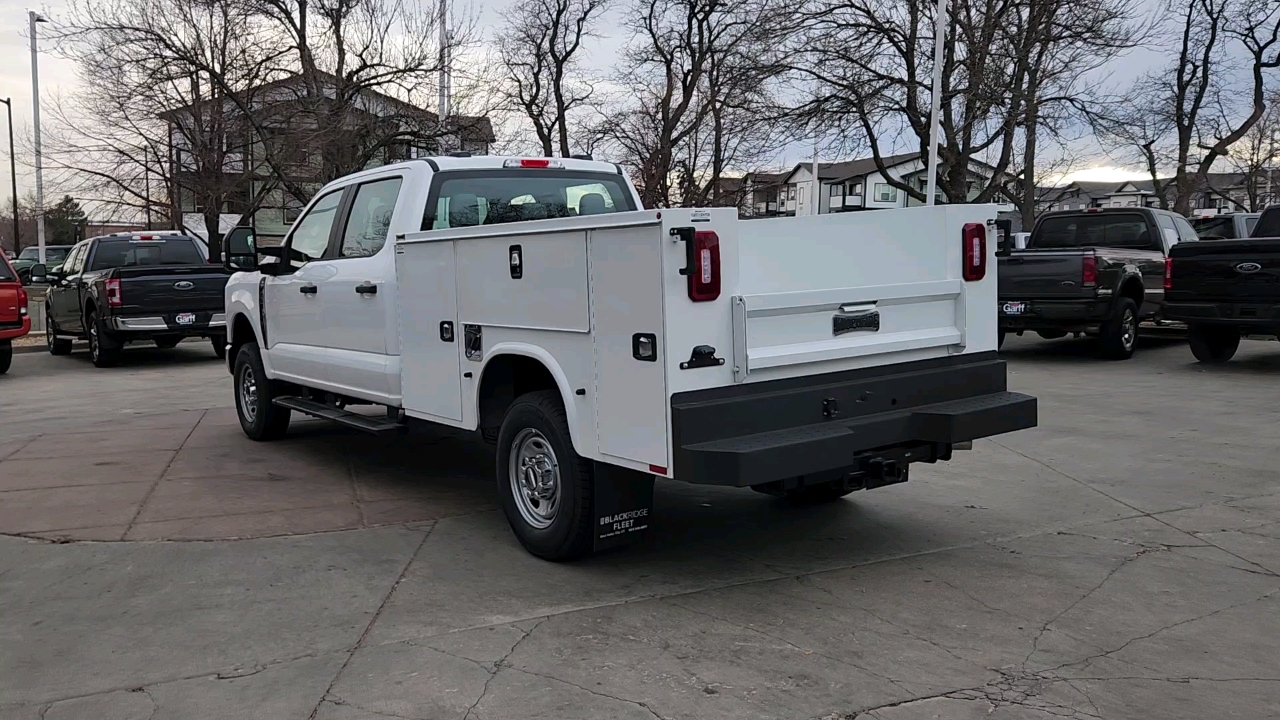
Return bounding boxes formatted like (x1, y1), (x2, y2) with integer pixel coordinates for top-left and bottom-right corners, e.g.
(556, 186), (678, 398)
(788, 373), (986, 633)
(671, 352), (1036, 487)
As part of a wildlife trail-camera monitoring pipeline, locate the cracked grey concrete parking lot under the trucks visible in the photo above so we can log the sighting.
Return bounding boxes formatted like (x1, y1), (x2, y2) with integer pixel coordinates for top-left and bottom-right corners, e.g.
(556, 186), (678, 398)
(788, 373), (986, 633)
(0, 338), (1280, 720)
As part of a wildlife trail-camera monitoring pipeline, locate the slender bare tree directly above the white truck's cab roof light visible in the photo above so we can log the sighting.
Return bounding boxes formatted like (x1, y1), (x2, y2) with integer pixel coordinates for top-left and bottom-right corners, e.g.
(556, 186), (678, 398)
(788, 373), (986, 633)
(498, 0), (605, 158)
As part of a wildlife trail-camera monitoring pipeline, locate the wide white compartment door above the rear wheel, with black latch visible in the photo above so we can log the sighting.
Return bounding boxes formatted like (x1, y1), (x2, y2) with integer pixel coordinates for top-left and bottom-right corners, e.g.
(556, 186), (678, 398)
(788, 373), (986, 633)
(457, 231), (591, 333)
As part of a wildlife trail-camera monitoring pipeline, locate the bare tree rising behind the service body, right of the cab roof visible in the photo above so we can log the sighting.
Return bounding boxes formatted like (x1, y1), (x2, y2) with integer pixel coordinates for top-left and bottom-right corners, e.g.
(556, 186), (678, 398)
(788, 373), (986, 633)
(600, 0), (788, 208)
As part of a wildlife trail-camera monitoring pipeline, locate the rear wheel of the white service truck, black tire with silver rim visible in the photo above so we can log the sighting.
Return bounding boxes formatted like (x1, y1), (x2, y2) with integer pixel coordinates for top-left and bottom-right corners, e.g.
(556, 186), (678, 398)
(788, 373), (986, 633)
(497, 391), (595, 561)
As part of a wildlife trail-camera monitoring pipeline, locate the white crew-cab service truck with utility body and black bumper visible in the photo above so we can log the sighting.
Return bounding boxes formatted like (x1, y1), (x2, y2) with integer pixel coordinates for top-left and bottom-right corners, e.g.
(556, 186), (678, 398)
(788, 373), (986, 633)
(225, 158), (1036, 560)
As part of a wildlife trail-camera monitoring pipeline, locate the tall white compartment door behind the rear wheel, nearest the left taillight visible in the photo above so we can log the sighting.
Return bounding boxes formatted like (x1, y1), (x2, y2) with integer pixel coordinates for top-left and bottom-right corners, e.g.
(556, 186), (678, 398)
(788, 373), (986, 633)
(590, 225), (671, 468)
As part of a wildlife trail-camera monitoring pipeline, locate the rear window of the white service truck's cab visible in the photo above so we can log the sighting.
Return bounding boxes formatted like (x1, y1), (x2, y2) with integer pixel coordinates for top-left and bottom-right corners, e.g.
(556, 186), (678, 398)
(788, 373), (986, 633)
(422, 169), (636, 229)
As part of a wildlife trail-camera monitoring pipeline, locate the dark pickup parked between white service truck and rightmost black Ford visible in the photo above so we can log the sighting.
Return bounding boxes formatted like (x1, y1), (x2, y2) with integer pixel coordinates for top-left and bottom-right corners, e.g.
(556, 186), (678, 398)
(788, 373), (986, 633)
(997, 208), (1198, 360)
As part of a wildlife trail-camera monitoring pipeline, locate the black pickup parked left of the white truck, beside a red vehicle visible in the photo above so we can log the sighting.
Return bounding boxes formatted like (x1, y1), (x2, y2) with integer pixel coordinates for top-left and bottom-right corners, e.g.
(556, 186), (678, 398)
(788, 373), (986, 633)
(31, 233), (230, 368)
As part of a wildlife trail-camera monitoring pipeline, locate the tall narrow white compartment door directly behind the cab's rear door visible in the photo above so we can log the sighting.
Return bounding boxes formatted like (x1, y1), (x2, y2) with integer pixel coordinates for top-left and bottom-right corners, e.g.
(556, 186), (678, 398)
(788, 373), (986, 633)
(396, 240), (462, 421)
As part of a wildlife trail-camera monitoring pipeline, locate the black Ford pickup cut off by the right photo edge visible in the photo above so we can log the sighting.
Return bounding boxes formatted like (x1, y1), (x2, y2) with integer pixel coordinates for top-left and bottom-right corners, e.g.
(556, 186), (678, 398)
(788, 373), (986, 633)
(1165, 205), (1280, 363)
